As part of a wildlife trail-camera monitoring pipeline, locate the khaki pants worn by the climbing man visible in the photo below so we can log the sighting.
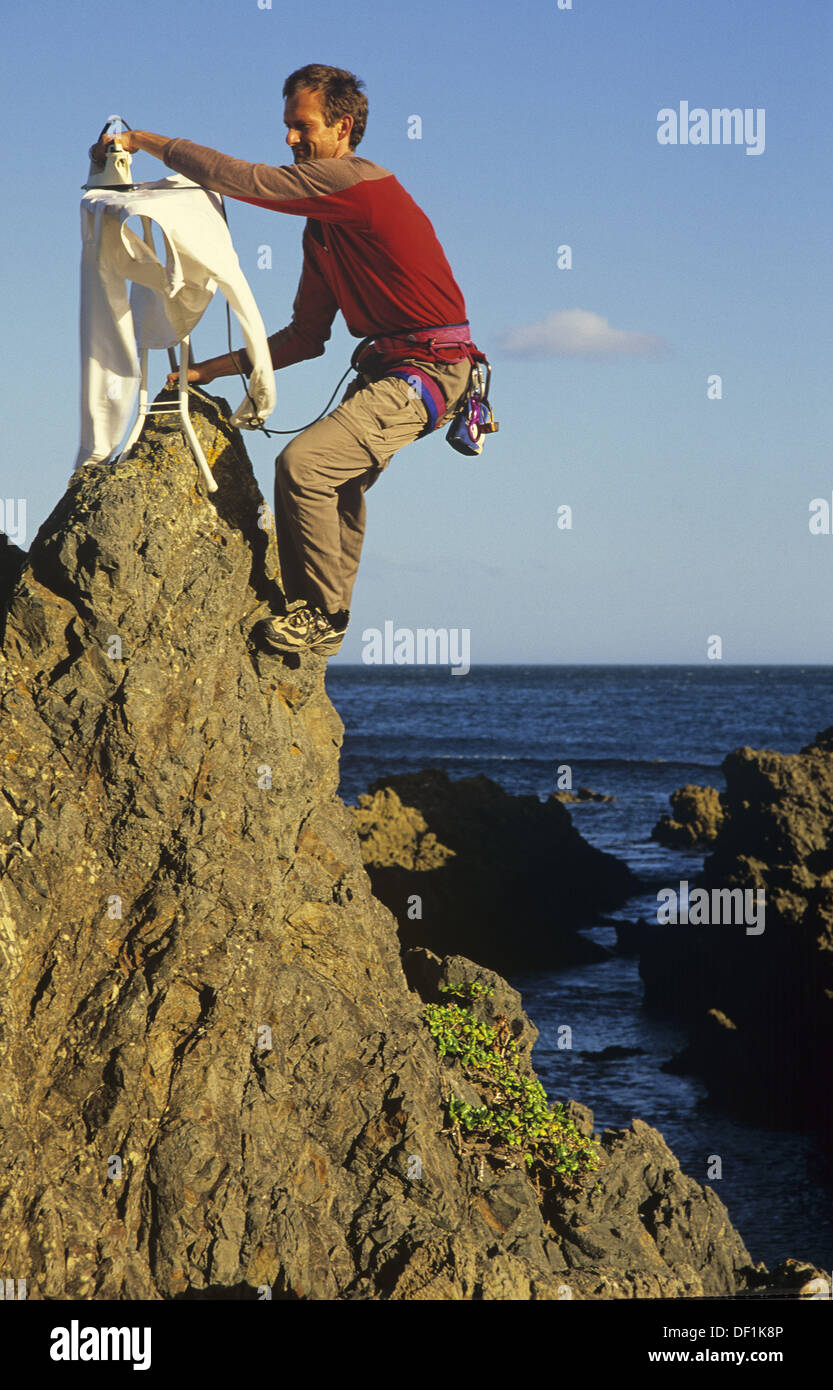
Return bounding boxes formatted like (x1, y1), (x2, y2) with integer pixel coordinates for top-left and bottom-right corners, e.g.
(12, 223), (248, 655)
(275, 359), (471, 613)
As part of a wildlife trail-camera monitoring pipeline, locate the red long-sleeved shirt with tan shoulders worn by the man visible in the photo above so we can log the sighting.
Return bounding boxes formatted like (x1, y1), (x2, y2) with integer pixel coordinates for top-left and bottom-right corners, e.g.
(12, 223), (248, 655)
(163, 139), (475, 368)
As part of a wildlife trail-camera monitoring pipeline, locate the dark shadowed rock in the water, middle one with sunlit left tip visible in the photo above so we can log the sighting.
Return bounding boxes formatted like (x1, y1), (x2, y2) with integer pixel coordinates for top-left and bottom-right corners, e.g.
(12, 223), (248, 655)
(353, 769), (638, 973)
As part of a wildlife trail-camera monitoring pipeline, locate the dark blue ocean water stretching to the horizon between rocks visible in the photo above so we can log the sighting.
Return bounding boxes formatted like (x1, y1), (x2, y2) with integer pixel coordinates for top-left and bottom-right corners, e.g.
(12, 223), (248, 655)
(327, 662), (833, 1269)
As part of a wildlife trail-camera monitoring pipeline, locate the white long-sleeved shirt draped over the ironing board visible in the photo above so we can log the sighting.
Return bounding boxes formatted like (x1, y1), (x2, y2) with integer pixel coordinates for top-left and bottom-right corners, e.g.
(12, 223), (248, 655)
(75, 174), (275, 468)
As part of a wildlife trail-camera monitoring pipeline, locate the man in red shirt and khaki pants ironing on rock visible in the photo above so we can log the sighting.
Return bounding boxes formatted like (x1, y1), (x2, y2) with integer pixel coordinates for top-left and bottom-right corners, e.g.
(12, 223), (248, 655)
(95, 64), (485, 656)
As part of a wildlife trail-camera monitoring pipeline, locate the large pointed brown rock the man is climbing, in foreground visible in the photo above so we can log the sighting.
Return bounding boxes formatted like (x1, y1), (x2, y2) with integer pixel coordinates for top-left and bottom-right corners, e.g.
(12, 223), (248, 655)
(0, 393), (812, 1300)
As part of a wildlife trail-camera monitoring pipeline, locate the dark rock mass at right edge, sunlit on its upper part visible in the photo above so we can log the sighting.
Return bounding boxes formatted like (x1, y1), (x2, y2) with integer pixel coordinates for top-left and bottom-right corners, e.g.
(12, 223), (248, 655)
(640, 727), (833, 1148)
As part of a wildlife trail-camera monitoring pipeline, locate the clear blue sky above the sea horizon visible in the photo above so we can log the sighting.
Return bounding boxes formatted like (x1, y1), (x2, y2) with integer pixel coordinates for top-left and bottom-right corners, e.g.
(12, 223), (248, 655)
(0, 0), (833, 663)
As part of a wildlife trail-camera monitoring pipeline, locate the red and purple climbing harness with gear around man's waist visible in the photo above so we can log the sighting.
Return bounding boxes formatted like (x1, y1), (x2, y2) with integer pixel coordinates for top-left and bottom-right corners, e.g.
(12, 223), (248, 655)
(350, 320), (499, 456)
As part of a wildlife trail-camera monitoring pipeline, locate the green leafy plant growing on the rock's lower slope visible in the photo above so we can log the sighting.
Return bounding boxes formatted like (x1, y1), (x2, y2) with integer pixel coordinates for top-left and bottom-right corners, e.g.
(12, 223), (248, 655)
(424, 986), (599, 1184)
